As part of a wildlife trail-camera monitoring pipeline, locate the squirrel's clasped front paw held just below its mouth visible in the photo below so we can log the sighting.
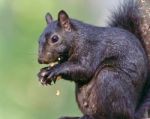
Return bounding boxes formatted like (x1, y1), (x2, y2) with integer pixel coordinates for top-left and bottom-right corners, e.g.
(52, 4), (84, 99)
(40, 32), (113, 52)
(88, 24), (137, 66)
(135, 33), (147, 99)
(38, 67), (57, 85)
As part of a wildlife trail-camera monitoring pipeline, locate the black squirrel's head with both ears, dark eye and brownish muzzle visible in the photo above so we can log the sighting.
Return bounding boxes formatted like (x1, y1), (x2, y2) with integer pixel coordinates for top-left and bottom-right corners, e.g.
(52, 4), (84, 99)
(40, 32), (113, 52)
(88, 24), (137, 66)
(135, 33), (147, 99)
(38, 10), (75, 64)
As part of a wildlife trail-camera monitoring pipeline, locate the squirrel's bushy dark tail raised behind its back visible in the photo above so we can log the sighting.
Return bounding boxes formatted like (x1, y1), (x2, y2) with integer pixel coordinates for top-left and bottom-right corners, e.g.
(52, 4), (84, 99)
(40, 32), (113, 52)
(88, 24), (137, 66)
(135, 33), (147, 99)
(108, 0), (148, 53)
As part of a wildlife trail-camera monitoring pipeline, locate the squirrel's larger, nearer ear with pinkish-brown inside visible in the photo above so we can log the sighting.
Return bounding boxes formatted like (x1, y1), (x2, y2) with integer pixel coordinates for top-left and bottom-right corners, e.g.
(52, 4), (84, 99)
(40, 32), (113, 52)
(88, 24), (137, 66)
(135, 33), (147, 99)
(58, 10), (71, 32)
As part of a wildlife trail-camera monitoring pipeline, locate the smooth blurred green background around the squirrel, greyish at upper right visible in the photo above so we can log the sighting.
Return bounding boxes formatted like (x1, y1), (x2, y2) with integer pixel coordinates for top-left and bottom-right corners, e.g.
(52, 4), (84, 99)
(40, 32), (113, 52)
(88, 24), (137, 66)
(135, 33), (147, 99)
(0, 0), (117, 119)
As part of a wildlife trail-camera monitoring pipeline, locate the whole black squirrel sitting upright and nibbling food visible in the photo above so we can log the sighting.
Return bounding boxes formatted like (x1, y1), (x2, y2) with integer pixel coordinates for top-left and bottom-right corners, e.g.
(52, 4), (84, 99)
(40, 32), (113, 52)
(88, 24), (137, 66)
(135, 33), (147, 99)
(38, 0), (150, 119)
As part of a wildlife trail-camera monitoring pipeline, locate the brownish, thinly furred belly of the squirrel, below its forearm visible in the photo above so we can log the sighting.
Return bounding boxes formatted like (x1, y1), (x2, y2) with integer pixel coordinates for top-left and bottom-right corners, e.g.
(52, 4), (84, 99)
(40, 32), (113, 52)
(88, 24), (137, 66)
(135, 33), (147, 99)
(76, 82), (98, 114)
